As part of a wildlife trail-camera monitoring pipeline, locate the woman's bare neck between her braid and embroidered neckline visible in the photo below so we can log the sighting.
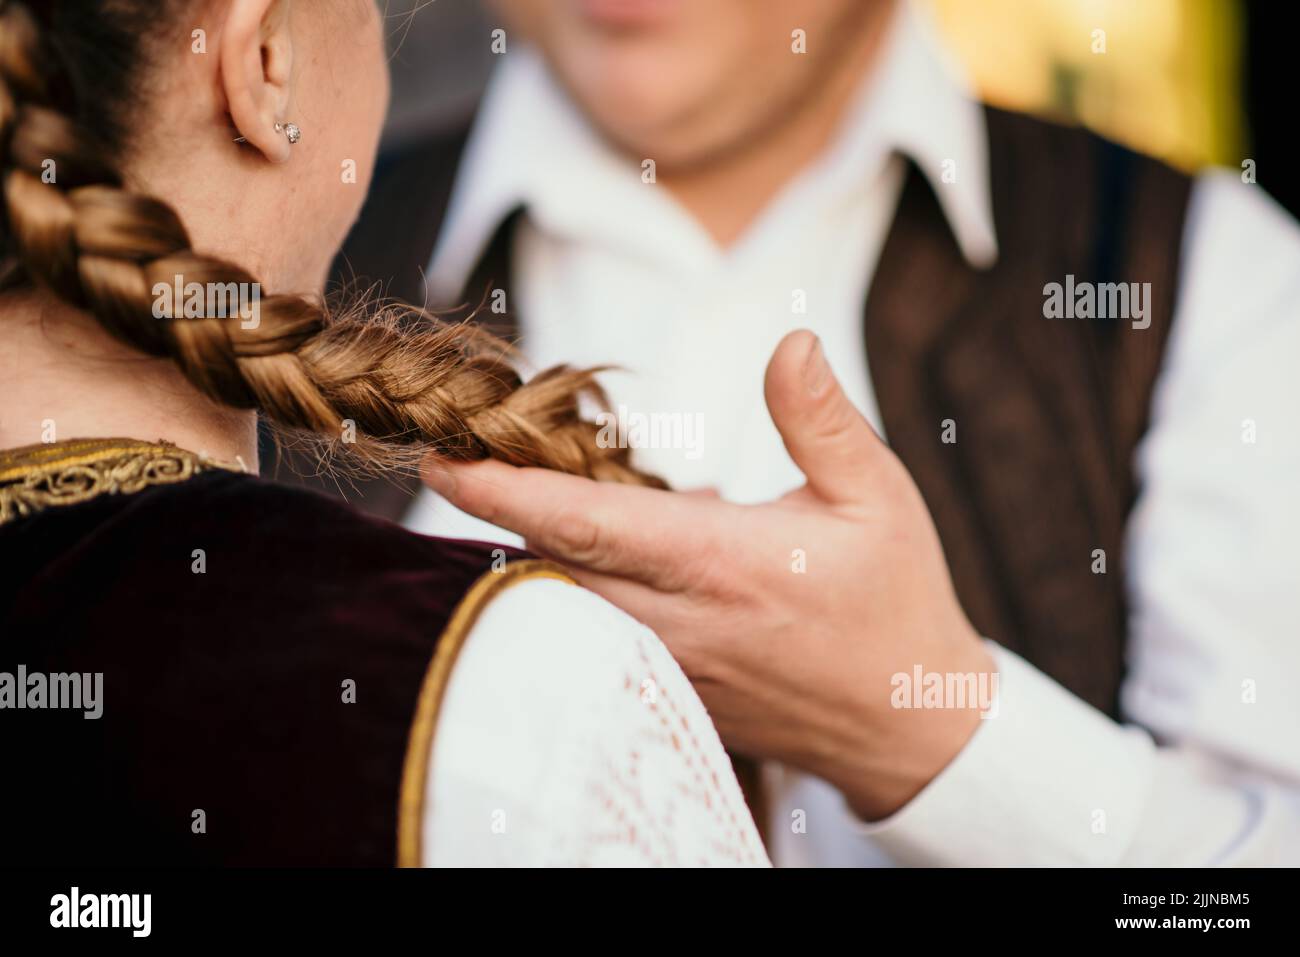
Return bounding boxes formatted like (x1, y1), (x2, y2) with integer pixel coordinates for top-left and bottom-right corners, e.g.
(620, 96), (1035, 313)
(0, 291), (257, 471)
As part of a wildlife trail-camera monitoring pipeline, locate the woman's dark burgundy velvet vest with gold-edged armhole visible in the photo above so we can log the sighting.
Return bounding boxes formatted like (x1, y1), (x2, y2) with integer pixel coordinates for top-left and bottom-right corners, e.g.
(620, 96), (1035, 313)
(0, 462), (538, 866)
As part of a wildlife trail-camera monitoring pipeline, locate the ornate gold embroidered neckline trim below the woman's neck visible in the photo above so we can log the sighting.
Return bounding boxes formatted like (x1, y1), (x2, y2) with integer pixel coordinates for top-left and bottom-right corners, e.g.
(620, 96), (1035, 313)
(0, 438), (243, 525)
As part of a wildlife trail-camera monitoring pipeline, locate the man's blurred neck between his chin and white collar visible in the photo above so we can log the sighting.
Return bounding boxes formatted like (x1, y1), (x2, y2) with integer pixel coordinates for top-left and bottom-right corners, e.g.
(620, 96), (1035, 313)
(659, 4), (897, 247)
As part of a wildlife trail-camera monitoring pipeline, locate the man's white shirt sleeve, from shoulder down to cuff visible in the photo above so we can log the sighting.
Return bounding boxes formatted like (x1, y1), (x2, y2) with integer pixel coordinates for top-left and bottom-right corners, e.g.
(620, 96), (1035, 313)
(842, 173), (1300, 866)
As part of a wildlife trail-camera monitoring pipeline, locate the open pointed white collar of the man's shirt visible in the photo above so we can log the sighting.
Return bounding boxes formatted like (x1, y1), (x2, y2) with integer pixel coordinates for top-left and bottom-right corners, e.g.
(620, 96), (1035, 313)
(429, 1), (997, 302)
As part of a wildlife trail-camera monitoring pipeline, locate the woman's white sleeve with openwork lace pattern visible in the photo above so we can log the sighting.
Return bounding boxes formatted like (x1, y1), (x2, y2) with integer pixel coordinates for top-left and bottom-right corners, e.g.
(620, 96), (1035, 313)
(424, 580), (768, 866)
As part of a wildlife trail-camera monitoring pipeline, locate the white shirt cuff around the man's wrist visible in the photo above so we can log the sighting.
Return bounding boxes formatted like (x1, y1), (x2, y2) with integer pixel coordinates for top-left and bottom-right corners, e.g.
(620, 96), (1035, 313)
(861, 642), (1156, 866)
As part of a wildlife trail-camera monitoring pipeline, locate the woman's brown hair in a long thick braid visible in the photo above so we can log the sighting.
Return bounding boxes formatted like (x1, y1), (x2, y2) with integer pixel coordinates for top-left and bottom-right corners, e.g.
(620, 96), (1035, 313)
(0, 0), (663, 486)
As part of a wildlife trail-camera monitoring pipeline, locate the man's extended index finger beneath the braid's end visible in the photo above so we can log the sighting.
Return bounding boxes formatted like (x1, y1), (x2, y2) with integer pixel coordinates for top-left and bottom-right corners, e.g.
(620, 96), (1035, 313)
(421, 458), (716, 590)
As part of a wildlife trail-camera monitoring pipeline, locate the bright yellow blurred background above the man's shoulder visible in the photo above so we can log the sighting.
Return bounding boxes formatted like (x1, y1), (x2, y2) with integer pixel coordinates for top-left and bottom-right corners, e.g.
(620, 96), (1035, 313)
(924, 0), (1242, 169)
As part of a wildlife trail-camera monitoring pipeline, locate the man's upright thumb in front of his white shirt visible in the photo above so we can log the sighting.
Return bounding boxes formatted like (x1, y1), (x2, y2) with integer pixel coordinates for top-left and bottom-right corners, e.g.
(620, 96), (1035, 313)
(763, 329), (889, 505)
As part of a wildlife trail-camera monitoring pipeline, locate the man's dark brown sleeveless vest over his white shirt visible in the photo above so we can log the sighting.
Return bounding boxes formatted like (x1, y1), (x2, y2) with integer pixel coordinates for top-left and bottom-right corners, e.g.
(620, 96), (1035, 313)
(319, 109), (1191, 714)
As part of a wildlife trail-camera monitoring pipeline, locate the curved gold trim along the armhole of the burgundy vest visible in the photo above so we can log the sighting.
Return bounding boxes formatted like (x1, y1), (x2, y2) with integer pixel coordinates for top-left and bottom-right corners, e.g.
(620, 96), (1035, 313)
(398, 558), (577, 867)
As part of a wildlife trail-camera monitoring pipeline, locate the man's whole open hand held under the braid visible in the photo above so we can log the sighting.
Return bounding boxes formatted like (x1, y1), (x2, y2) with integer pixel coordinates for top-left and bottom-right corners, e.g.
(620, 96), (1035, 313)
(425, 332), (992, 819)
